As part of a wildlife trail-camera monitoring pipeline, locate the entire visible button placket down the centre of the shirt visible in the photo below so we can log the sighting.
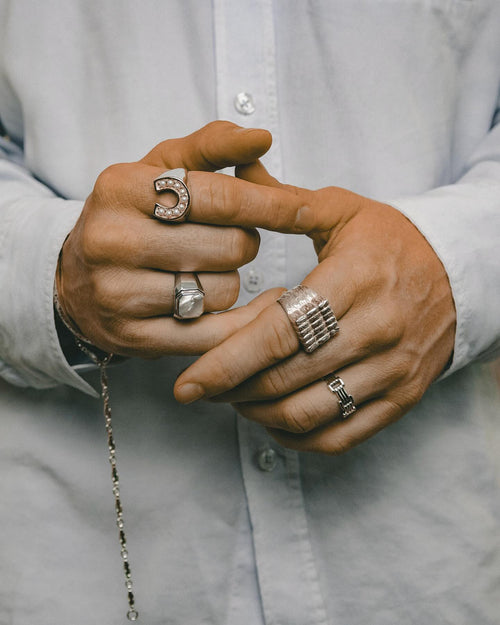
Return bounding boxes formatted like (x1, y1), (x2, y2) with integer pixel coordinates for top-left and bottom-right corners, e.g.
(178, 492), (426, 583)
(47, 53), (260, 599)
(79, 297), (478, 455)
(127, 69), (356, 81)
(214, 0), (327, 625)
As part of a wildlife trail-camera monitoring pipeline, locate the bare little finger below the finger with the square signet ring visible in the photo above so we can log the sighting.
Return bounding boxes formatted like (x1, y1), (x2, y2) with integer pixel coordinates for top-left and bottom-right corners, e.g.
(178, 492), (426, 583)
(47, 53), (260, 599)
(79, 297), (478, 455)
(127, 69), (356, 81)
(93, 289), (279, 358)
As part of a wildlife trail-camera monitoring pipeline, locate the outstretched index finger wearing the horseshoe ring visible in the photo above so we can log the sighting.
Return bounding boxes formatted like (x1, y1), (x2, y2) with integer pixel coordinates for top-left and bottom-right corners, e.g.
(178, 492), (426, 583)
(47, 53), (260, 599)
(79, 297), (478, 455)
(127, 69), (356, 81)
(93, 142), (354, 239)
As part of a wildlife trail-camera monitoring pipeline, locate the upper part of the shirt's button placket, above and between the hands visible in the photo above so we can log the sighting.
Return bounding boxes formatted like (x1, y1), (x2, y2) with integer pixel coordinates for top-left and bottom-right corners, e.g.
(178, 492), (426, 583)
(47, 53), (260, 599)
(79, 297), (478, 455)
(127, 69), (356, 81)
(214, 0), (286, 305)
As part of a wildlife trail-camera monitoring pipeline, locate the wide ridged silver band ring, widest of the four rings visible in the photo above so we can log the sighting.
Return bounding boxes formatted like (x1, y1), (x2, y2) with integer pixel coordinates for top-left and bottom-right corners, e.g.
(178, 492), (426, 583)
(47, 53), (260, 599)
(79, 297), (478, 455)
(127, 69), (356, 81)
(278, 284), (339, 353)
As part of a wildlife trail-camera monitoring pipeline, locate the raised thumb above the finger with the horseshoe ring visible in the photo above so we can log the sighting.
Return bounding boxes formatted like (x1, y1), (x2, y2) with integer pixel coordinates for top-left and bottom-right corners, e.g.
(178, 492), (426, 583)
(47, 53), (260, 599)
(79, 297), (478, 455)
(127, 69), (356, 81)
(142, 121), (272, 171)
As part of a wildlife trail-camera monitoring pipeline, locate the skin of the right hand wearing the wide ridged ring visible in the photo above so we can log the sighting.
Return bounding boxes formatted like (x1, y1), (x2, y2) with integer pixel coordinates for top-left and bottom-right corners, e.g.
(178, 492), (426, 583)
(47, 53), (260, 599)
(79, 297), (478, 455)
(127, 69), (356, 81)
(174, 162), (456, 454)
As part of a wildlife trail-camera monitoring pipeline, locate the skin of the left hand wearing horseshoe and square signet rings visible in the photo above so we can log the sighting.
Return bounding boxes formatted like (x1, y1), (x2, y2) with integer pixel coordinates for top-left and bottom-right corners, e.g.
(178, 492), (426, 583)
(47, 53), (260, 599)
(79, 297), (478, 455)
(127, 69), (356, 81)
(56, 122), (286, 358)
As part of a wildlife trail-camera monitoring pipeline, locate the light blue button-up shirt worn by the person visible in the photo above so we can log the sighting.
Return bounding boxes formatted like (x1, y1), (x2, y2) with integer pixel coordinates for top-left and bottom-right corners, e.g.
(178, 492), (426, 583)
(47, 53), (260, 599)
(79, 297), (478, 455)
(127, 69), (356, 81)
(0, 0), (500, 625)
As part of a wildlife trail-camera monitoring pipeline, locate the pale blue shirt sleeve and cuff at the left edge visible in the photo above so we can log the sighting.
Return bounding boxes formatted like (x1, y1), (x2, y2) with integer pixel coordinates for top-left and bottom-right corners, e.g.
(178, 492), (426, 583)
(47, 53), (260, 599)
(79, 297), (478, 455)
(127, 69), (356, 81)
(0, 138), (95, 395)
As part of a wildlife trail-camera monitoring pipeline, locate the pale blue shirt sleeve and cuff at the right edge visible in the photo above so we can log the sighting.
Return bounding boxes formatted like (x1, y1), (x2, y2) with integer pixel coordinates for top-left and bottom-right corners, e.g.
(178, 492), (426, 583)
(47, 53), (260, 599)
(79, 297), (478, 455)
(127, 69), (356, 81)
(389, 109), (500, 375)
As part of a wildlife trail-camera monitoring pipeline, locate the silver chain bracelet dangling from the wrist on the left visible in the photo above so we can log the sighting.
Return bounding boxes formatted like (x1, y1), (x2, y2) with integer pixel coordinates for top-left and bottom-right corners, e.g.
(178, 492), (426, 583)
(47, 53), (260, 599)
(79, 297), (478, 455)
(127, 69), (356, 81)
(54, 282), (139, 621)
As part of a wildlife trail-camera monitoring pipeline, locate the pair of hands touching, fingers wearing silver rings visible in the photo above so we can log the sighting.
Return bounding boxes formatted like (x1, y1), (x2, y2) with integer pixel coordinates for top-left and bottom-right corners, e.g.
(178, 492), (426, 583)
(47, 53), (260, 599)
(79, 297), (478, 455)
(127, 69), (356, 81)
(58, 122), (455, 454)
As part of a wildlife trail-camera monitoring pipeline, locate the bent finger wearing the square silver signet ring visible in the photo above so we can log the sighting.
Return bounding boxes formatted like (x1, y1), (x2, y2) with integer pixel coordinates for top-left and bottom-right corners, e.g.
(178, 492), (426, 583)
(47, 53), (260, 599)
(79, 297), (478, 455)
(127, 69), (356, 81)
(94, 268), (240, 319)
